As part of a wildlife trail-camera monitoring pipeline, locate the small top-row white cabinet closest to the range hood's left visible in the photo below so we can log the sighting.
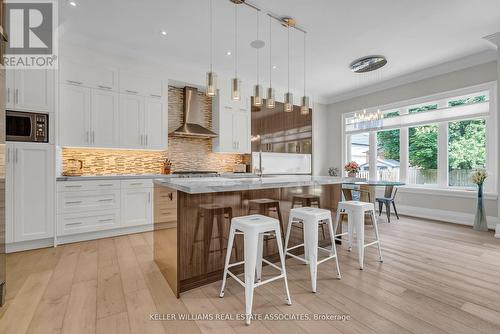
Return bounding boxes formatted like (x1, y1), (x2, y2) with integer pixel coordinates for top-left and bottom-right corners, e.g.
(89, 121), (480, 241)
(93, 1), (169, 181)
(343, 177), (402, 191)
(120, 70), (164, 98)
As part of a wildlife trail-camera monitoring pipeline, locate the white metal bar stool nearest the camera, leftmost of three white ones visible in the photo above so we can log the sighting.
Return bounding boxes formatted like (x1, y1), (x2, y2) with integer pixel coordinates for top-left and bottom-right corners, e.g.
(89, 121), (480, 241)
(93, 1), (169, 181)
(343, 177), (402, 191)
(220, 215), (292, 325)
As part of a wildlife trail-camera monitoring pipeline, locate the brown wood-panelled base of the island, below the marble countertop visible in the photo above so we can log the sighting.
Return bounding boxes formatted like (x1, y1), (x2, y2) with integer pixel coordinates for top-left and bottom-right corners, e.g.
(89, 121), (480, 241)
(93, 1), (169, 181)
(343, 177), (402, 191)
(154, 183), (342, 297)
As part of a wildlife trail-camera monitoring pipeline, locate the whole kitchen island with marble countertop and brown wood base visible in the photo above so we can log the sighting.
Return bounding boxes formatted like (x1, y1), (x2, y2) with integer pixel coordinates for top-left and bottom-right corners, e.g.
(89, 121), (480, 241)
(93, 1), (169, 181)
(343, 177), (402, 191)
(154, 176), (345, 297)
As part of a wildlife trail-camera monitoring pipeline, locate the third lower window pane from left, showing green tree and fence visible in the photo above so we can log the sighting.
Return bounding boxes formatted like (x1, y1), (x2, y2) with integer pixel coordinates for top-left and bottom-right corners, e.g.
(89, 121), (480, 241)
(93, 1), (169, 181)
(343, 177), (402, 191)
(407, 124), (438, 184)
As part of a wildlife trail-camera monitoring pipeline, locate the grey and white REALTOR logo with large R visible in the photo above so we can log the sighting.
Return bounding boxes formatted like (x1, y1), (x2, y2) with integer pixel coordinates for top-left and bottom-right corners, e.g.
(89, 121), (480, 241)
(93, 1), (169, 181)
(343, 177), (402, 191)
(4, 0), (57, 69)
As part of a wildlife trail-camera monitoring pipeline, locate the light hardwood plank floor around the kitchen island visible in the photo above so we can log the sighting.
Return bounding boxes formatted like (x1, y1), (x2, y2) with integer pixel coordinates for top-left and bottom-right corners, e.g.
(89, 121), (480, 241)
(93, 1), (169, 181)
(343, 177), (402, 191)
(0, 218), (500, 334)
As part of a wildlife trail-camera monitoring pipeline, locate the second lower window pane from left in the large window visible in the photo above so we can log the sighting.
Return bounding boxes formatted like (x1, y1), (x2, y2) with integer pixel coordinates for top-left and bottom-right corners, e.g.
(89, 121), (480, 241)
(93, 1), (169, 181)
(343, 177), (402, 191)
(377, 129), (400, 181)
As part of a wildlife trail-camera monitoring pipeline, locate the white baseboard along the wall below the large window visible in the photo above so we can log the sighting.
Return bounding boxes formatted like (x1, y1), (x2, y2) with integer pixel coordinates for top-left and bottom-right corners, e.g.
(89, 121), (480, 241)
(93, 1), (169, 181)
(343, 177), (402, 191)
(397, 205), (500, 231)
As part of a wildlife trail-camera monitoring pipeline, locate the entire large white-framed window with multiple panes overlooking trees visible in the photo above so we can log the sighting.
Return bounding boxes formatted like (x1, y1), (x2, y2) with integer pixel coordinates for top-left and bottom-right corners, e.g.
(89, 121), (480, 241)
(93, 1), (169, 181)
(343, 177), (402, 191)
(343, 84), (498, 193)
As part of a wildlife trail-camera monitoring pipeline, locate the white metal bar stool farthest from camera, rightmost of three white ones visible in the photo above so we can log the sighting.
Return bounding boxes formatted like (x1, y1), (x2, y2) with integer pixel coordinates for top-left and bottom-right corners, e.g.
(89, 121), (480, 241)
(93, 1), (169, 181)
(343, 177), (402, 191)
(334, 201), (384, 270)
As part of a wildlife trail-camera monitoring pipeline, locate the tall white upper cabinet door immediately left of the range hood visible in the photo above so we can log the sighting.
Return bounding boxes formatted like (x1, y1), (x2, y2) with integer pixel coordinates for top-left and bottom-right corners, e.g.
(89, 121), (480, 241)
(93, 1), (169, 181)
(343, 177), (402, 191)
(145, 98), (168, 150)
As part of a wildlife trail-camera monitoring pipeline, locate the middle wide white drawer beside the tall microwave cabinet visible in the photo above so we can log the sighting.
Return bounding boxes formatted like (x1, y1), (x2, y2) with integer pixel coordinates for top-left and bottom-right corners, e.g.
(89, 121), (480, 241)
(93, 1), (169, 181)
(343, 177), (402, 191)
(57, 190), (120, 214)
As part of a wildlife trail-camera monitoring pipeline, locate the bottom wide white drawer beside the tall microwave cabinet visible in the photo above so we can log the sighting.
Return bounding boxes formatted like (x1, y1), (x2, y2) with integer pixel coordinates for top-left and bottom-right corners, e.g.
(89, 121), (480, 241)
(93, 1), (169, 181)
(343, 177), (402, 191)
(57, 210), (120, 236)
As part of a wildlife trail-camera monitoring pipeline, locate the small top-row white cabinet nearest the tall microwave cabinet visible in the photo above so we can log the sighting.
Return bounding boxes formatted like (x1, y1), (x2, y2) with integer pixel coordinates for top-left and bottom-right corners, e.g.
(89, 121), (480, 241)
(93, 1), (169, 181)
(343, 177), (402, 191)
(61, 61), (118, 91)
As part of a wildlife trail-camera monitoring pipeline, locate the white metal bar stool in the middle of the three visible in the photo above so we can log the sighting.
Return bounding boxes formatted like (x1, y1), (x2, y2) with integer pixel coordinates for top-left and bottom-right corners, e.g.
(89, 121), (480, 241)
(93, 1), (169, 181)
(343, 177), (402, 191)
(285, 207), (341, 292)
